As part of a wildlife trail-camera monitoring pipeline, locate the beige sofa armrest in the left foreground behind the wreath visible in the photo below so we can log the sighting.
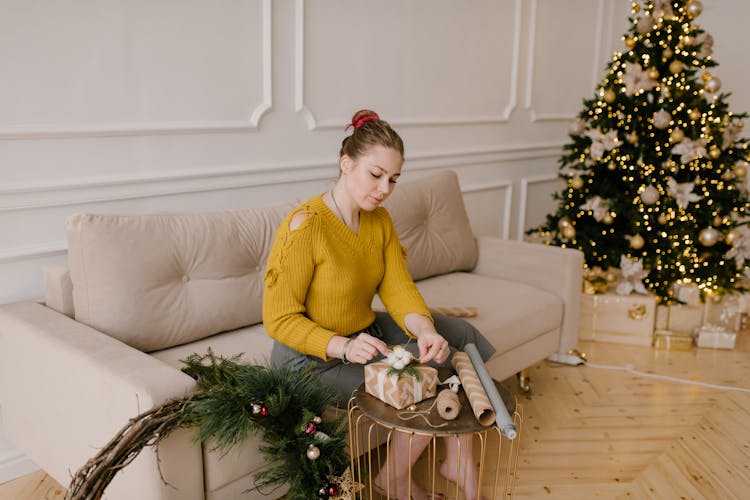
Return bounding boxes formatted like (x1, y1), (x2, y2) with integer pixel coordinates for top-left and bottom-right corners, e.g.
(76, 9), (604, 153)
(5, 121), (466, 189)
(0, 302), (204, 499)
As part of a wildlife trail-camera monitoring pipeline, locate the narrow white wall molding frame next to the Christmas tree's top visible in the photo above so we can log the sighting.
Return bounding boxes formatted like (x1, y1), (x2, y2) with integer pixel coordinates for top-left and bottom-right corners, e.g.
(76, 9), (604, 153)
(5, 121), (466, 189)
(526, 0), (612, 123)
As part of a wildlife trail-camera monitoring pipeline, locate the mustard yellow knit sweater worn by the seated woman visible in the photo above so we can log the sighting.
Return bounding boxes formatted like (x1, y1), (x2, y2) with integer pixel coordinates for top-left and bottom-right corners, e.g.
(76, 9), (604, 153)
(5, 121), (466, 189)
(263, 195), (430, 360)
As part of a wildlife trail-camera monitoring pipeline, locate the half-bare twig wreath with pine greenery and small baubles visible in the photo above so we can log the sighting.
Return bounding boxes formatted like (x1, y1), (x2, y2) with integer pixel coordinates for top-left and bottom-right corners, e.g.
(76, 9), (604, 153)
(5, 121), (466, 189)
(65, 350), (352, 500)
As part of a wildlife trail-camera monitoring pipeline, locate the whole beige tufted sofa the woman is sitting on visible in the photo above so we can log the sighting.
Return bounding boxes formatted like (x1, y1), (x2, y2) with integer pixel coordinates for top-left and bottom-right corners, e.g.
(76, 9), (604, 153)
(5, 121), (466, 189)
(0, 171), (583, 500)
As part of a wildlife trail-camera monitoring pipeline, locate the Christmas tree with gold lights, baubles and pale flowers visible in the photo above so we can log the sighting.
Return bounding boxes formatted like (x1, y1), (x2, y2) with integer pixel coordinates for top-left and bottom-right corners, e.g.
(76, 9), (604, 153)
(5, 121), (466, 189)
(529, 0), (750, 304)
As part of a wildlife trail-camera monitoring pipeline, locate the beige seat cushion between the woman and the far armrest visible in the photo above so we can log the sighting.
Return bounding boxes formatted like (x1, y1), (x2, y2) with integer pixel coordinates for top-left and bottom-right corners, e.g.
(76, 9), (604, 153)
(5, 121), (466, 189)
(417, 273), (563, 353)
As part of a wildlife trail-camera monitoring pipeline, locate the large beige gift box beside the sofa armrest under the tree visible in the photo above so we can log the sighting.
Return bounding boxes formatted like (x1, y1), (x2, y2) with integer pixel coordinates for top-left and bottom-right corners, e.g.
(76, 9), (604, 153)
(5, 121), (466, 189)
(578, 293), (656, 345)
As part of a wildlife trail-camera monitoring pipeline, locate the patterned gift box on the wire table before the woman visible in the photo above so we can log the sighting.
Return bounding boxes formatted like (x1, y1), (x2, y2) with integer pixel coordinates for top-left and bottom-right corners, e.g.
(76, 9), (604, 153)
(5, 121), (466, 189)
(365, 361), (437, 410)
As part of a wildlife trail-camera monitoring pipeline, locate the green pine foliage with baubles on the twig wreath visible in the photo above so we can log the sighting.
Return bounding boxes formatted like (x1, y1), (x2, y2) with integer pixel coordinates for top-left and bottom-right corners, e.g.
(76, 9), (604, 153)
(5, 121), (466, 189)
(183, 351), (349, 500)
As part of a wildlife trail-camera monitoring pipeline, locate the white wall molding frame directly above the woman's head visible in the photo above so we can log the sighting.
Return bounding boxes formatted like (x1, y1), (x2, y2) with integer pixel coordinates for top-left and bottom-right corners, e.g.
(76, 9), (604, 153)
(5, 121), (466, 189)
(294, 0), (523, 130)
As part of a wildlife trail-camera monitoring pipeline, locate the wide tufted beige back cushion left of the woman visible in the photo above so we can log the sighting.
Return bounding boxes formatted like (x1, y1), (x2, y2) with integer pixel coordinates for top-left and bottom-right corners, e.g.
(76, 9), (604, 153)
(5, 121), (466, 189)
(67, 202), (295, 352)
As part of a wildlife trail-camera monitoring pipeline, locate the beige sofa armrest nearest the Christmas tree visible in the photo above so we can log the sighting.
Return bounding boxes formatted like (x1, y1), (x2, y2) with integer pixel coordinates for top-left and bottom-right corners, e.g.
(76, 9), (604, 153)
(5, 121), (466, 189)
(473, 236), (583, 353)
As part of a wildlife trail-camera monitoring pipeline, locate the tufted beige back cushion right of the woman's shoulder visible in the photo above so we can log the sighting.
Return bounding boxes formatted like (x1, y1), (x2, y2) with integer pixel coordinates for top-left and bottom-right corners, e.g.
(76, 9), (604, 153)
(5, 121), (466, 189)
(384, 170), (478, 280)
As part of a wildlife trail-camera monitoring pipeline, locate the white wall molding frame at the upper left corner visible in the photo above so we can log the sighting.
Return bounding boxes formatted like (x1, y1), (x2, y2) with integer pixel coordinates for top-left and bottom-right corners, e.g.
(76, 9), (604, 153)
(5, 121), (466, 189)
(0, 0), (273, 140)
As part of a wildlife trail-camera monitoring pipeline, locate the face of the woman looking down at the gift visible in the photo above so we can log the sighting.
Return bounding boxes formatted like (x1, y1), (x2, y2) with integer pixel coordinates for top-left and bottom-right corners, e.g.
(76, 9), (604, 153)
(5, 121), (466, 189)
(339, 146), (404, 211)
